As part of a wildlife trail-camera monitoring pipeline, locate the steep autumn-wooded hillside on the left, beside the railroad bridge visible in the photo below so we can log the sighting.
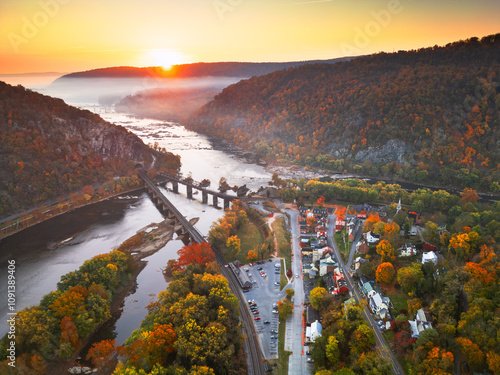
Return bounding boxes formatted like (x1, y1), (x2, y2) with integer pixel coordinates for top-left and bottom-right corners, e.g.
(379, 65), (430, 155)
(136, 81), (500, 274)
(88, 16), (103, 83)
(0, 82), (180, 215)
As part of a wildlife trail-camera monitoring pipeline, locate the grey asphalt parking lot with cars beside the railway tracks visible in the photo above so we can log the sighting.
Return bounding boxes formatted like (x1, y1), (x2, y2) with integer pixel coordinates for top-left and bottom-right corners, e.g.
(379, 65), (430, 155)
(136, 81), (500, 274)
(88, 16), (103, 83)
(242, 258), (285, 359)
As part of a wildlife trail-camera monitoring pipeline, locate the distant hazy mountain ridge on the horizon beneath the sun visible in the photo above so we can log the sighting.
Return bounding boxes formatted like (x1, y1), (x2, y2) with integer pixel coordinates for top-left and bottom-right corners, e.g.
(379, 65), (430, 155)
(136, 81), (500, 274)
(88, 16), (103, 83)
(50, 57), (352, 84)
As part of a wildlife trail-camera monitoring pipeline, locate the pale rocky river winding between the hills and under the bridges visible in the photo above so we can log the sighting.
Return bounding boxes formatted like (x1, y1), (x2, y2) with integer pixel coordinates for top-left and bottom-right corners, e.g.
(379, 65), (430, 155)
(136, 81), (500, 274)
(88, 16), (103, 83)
(0, 97), (271, 344)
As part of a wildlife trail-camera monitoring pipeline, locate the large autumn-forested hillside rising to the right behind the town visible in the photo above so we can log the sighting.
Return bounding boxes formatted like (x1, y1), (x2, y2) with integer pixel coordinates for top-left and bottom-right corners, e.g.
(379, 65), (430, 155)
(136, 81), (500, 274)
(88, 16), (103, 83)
(189, 34), (500, 192)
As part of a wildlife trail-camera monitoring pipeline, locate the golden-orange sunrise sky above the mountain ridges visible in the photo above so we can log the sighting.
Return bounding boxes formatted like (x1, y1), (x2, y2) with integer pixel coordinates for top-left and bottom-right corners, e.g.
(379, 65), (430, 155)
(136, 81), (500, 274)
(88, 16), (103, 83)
(0, 0), (500, 74)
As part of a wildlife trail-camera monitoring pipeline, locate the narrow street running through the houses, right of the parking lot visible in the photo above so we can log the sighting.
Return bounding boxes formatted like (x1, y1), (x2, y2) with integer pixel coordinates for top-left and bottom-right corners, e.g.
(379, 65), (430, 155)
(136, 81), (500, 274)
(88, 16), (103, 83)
(328, 215), (404, 375)
